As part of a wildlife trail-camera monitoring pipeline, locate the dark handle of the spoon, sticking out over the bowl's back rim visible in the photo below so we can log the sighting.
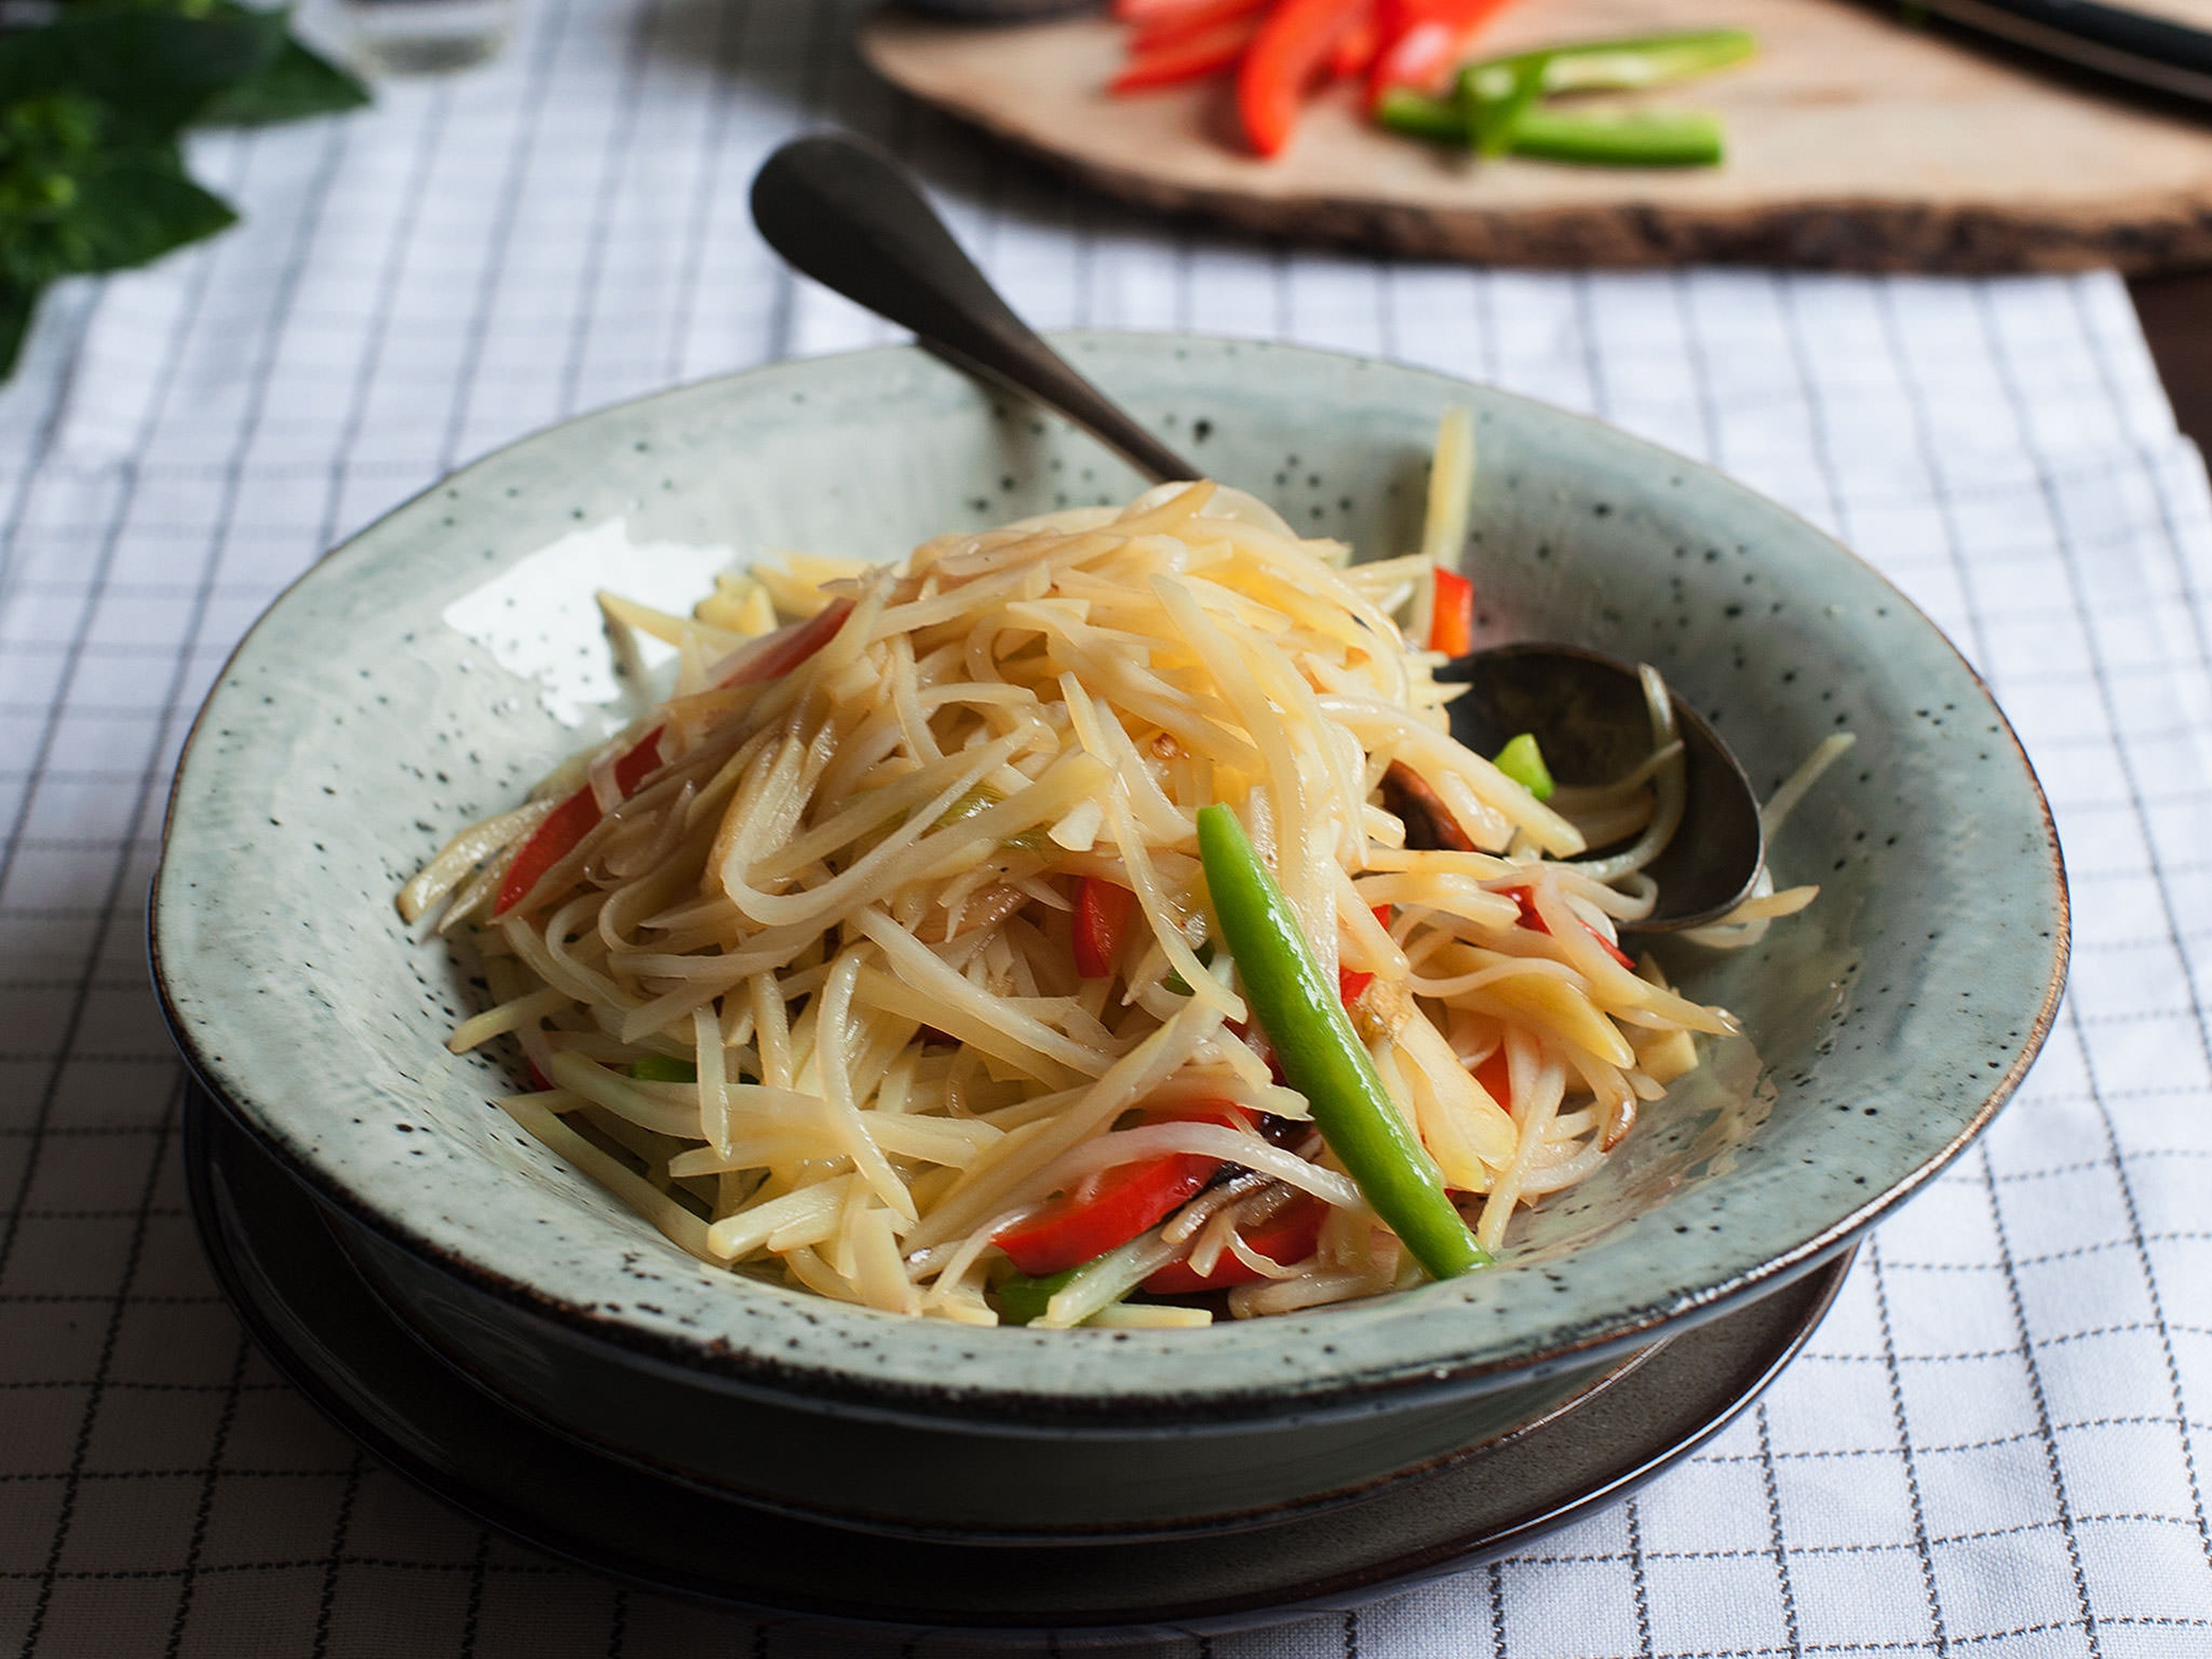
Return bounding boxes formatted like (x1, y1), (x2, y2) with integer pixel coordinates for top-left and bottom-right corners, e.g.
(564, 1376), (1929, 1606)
(752, 132), (1201, 482)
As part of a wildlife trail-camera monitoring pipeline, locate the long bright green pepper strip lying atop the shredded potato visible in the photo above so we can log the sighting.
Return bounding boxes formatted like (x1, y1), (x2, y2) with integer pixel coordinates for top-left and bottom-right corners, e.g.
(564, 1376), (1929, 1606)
(1199, 803), (1491, 1279)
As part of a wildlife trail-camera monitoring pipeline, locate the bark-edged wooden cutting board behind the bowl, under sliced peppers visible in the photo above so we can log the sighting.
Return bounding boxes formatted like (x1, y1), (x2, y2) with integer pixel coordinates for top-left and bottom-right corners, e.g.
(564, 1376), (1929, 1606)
(861, 0), (2212, 272)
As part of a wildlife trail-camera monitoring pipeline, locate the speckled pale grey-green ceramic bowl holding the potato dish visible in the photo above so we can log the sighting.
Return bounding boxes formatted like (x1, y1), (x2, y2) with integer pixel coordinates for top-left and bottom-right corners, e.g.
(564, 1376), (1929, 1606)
(153, 334), (2066, 1531)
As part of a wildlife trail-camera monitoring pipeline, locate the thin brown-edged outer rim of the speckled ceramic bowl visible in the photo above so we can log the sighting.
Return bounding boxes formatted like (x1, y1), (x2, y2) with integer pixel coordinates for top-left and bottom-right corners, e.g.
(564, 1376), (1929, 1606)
(146, 329), (2073, 1435)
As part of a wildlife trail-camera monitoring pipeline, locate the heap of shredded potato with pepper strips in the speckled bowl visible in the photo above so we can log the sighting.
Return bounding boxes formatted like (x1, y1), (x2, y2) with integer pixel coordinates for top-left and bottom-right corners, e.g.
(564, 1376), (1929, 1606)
(400, 411), (1832, 1327)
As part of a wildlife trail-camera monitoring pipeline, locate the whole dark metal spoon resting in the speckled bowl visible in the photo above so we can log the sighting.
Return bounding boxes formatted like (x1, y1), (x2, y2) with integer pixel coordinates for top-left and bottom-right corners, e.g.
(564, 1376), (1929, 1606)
(752, 132), (1765, 933)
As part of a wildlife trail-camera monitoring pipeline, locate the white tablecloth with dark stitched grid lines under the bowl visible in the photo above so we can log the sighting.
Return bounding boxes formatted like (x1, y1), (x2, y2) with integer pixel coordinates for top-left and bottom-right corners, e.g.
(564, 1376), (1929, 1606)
(0, 0), (2212, 1659)
